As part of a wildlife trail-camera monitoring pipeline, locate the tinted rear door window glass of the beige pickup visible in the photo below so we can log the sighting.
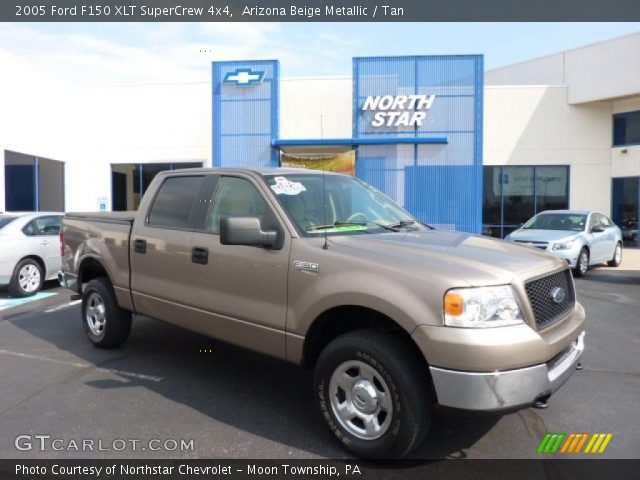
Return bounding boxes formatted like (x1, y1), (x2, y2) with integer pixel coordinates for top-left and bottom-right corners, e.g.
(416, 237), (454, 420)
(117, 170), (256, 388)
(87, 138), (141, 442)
(147, 176), (203, 228)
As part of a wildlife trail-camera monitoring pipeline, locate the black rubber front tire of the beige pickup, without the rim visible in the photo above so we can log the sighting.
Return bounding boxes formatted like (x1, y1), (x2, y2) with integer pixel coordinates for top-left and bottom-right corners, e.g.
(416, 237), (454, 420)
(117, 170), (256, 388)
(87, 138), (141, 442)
(314, 330), (433, 459)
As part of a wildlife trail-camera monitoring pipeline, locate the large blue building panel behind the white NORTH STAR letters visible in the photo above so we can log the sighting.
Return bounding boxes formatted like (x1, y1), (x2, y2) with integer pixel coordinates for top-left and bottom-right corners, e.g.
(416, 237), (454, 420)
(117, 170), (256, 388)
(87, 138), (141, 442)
(353, 55), (484, 233)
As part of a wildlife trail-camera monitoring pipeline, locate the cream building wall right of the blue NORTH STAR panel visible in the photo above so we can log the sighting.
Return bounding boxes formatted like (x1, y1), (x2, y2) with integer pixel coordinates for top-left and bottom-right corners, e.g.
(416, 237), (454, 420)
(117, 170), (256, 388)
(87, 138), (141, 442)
(483, 86), (612, 213)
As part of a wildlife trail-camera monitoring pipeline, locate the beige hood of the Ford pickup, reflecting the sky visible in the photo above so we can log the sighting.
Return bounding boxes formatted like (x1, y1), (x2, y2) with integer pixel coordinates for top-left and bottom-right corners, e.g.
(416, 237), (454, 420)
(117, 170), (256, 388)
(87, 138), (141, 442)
(331, 230), (566, 286)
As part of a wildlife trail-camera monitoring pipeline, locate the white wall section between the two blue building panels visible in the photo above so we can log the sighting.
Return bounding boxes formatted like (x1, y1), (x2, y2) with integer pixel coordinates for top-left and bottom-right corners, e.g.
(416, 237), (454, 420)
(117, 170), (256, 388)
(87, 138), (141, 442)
(280, 77), (353, 139)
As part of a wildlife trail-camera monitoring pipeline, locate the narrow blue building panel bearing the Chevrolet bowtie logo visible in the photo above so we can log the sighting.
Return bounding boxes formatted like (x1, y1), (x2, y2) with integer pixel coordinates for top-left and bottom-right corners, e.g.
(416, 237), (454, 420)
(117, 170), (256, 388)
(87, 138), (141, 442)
(212, 60), (280, 167)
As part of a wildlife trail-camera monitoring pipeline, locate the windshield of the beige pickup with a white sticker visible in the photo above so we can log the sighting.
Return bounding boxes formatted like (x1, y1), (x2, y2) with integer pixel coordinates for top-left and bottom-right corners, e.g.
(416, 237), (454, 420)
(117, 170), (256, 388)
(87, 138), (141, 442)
(265, 173), (426, 236)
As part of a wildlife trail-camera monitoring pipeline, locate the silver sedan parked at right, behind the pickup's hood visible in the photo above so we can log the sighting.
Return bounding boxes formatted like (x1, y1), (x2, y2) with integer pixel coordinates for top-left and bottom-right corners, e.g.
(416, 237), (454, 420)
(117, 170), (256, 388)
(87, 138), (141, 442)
(506, 210), (622, 277)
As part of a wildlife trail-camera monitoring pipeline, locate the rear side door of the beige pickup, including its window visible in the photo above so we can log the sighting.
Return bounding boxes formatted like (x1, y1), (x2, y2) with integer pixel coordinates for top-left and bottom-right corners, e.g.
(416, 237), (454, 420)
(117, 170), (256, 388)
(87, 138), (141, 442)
(129, 175), (204, 324)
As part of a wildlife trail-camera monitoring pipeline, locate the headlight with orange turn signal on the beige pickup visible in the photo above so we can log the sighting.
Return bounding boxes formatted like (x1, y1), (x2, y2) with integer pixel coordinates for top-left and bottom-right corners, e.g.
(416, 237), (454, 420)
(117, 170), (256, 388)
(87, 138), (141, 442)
(444, 285), (524, 328)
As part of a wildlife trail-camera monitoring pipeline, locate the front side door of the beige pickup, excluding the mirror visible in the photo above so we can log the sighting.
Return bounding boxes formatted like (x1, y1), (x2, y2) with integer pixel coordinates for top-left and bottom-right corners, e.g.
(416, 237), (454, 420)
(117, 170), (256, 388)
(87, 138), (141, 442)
(188, 174), (291, 357)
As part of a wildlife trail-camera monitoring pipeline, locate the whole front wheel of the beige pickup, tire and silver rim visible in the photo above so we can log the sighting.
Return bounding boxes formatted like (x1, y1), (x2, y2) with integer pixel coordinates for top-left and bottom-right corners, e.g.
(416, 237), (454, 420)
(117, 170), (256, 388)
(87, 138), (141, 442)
(314, 330), (433, 458)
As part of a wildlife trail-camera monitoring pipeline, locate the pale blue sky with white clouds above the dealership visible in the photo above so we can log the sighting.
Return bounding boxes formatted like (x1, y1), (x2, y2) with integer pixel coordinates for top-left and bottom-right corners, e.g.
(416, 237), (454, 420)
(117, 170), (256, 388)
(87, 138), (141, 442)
(0, 22), (640, 84)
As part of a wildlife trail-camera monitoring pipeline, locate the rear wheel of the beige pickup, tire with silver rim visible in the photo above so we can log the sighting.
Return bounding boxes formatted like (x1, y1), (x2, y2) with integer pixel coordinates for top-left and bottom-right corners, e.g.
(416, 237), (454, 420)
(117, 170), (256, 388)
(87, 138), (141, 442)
(82, 278), (131, 348)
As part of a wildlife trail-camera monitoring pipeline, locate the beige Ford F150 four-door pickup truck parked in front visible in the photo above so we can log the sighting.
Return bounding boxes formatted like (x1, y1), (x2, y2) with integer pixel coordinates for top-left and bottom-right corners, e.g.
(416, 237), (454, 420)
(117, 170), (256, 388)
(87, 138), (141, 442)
(60, 168), (585, 458)
